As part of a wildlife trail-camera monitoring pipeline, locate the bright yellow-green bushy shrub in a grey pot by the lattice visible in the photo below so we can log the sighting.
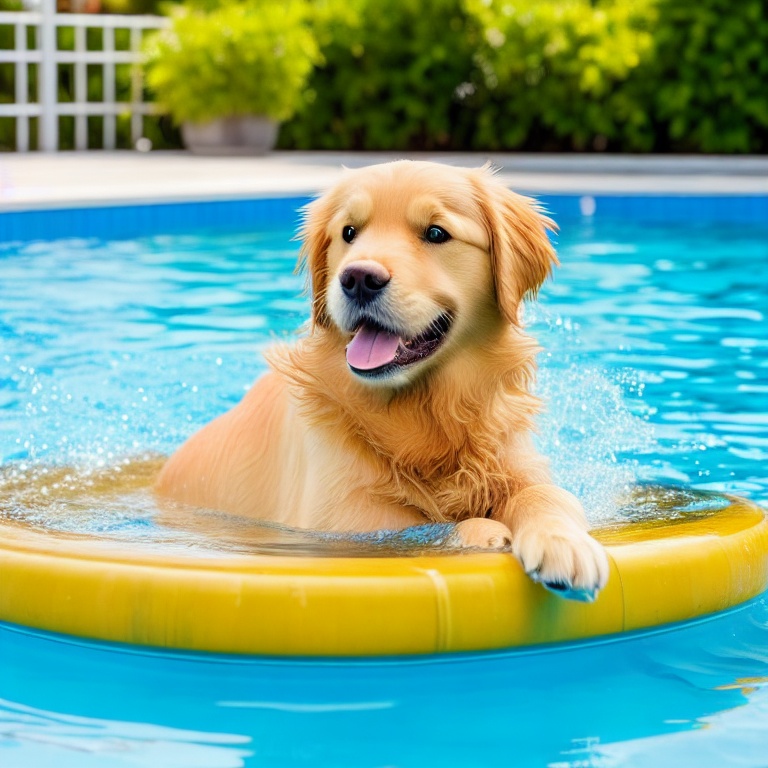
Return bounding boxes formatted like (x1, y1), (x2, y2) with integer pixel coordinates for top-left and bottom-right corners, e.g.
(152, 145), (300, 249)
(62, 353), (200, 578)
(144, 0), (320, 154)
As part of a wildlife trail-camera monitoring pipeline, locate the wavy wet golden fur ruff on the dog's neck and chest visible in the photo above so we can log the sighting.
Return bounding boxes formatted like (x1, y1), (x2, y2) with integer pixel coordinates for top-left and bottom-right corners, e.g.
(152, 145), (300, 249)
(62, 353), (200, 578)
(270, 333), (537, 522)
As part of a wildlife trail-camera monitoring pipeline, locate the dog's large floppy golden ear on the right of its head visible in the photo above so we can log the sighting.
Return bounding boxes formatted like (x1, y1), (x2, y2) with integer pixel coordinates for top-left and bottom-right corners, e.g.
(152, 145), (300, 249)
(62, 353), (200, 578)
(471, 166), (558, 324)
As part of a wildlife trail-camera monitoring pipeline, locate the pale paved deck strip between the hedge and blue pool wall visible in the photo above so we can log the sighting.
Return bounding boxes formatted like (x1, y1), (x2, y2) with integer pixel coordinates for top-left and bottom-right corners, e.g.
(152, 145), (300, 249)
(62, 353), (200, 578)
(0, 151), (768, 212)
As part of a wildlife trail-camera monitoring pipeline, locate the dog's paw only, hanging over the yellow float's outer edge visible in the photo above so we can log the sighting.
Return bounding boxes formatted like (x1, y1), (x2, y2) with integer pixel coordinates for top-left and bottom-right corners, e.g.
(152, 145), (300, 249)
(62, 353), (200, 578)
(512, 525), (609, 602)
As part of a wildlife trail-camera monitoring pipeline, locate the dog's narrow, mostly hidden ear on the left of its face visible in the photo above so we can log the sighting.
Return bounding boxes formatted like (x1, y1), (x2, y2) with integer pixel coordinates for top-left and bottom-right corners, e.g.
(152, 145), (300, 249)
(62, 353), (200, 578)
(297, 195), (334, 330)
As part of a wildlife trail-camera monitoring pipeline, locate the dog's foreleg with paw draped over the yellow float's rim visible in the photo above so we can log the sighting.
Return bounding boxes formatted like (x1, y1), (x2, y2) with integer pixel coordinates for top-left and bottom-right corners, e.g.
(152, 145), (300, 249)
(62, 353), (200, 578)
(494, 484), (608, 593)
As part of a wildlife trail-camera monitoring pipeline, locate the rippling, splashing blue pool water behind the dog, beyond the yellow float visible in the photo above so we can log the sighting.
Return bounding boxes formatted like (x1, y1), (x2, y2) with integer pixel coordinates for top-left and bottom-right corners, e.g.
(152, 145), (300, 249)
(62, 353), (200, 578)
(0, 216), (768, 518)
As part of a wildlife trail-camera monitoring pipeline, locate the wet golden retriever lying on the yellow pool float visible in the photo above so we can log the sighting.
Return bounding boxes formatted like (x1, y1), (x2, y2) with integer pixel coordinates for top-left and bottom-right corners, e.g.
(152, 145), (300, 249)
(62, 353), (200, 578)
(157, 161), (608, 591)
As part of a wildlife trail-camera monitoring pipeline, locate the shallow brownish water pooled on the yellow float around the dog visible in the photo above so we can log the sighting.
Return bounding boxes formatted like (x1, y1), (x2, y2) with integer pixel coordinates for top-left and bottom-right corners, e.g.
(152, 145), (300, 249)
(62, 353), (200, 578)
(0, 457), (744, 557)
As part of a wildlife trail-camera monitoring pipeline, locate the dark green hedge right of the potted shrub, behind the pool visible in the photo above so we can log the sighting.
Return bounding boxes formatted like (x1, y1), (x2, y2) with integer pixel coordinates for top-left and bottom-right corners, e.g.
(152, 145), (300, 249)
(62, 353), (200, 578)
(281, 0), (768, 152)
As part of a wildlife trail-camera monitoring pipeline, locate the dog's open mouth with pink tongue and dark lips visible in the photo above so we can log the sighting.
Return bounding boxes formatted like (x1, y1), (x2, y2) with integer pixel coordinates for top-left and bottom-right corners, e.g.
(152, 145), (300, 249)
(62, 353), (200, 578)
(347, 312), (453, 378)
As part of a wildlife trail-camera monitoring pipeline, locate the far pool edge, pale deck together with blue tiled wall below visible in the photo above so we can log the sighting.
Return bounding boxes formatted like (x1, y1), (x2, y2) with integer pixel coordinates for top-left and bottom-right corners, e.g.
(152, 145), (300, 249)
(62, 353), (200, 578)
(0, 152), (768, 236)
